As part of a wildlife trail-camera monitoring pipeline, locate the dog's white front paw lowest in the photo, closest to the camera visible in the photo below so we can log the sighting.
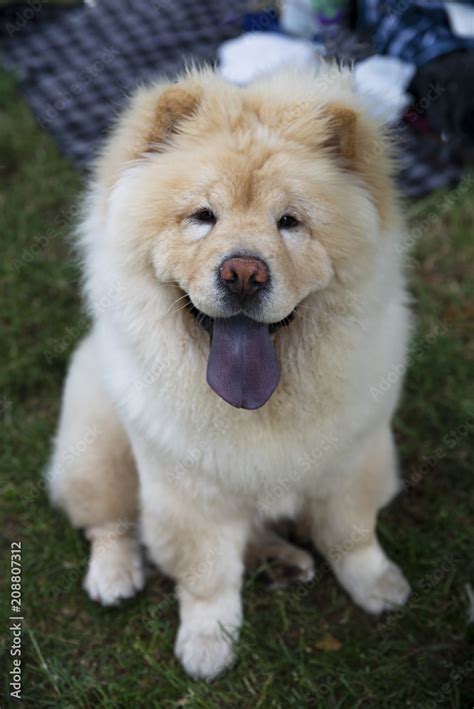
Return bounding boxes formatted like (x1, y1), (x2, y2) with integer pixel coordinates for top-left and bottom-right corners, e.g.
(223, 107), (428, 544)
(175, 625), (235, 682)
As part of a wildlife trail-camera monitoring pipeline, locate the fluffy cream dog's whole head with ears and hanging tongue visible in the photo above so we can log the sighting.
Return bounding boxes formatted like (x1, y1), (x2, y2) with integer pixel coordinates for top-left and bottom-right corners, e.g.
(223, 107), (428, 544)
(92, 71), (391, 408)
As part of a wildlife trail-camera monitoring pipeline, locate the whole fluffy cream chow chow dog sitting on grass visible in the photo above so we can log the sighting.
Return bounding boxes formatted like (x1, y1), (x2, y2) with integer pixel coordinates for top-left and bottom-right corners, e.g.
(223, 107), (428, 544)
(48, 67), (410, 680)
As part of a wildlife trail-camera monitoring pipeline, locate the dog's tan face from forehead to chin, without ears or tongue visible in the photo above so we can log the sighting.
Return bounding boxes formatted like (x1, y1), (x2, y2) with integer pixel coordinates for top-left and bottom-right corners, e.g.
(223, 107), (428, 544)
(146, 144), (333, 324)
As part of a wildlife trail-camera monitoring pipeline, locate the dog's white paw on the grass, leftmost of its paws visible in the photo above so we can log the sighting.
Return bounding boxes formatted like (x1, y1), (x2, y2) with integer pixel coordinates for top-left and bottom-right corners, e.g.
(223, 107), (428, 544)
(84, 539), (145, 606)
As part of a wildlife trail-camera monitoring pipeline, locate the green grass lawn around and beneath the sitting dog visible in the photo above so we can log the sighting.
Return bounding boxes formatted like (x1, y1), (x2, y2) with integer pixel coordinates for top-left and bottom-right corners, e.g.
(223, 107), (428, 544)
(0, 68), (474, 709)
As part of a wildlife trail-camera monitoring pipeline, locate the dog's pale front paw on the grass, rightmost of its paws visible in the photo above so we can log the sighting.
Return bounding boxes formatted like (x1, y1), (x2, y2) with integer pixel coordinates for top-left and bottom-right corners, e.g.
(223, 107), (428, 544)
(337, 550), (410, 614)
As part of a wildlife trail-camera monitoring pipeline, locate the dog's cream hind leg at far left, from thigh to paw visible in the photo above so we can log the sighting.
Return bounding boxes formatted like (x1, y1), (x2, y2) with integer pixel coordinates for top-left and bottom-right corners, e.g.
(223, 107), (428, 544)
(47, 338), (144, 605)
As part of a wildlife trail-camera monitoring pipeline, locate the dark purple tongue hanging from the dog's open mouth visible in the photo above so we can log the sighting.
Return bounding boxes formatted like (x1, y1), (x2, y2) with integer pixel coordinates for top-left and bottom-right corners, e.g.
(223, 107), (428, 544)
(207, 315), (280, 409)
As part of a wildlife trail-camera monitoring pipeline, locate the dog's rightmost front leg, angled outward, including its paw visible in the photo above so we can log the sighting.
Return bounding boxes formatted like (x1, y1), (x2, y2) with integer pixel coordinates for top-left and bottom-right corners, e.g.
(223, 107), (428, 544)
(310, 428), (410, 613)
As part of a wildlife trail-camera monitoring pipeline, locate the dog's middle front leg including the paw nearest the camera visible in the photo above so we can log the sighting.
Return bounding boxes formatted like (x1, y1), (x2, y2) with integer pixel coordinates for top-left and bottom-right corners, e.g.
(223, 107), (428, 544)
(136, 448), (249, 681)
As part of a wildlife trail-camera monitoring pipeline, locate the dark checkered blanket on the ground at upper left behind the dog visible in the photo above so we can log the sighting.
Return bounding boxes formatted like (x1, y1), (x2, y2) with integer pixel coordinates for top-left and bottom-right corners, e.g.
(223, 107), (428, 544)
(3, 0), (244, 166)
